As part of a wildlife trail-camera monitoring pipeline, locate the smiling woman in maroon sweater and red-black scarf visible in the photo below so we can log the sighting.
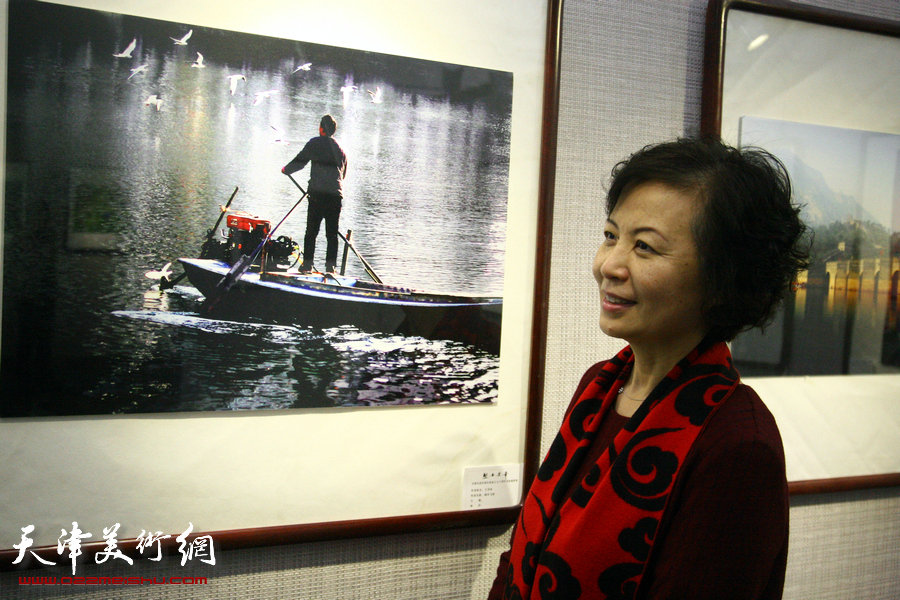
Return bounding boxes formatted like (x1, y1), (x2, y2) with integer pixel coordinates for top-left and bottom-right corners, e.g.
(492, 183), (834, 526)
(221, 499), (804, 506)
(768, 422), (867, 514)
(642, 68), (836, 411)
(490, 140), (808, 600)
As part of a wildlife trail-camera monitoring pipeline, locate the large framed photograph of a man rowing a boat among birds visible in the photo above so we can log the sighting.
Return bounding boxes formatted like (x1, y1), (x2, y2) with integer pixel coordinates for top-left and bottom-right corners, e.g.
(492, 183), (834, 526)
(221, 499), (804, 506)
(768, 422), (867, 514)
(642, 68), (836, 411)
(0, 0), (561, 567)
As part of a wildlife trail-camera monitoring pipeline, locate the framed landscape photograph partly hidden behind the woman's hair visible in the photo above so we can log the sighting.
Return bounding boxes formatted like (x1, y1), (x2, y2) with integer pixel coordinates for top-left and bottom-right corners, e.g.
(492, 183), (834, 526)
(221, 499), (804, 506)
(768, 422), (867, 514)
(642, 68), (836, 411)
(702, 0), (900, 493)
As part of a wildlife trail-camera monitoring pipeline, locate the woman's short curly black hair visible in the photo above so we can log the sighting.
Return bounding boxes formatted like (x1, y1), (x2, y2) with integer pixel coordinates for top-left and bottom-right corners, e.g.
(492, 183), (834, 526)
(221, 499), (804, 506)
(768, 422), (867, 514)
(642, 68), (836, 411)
(606, 137), (810, 341)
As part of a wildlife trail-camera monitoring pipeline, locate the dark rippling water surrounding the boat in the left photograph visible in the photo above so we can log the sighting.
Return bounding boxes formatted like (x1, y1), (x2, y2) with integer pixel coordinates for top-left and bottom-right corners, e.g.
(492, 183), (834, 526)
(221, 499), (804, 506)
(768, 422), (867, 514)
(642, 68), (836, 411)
(0, 3), (512, 416)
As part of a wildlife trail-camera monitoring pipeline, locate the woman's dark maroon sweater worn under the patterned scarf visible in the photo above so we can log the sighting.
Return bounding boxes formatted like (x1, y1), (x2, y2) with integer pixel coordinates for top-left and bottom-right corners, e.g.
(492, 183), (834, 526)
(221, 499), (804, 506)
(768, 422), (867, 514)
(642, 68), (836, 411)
(488, 365), (788, 600)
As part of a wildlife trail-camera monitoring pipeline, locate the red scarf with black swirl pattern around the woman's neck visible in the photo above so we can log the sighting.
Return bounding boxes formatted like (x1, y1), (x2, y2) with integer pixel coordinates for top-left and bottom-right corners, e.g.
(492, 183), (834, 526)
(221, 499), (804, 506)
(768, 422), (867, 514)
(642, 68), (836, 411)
(504, 343), (739, 600)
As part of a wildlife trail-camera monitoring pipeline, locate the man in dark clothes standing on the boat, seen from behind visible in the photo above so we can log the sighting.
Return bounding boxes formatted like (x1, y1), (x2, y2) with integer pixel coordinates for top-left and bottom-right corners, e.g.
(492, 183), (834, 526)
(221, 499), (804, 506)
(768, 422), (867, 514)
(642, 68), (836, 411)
(281, 115), (347, 273)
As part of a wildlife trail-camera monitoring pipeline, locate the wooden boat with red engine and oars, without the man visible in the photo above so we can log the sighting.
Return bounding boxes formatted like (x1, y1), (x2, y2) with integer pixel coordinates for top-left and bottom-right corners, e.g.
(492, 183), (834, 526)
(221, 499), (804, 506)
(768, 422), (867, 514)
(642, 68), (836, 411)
(160, 184), (503, 354)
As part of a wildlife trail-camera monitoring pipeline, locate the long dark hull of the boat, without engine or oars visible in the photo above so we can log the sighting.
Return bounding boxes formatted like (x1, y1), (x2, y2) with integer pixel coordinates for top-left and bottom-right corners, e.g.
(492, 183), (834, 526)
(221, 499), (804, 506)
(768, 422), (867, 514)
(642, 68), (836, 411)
(179, 258), (503, 354)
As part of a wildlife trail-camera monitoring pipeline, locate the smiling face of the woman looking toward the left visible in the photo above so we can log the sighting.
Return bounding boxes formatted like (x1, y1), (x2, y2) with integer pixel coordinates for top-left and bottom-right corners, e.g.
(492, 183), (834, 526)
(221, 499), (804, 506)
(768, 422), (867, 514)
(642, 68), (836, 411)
(593, 182), (708, 348)
